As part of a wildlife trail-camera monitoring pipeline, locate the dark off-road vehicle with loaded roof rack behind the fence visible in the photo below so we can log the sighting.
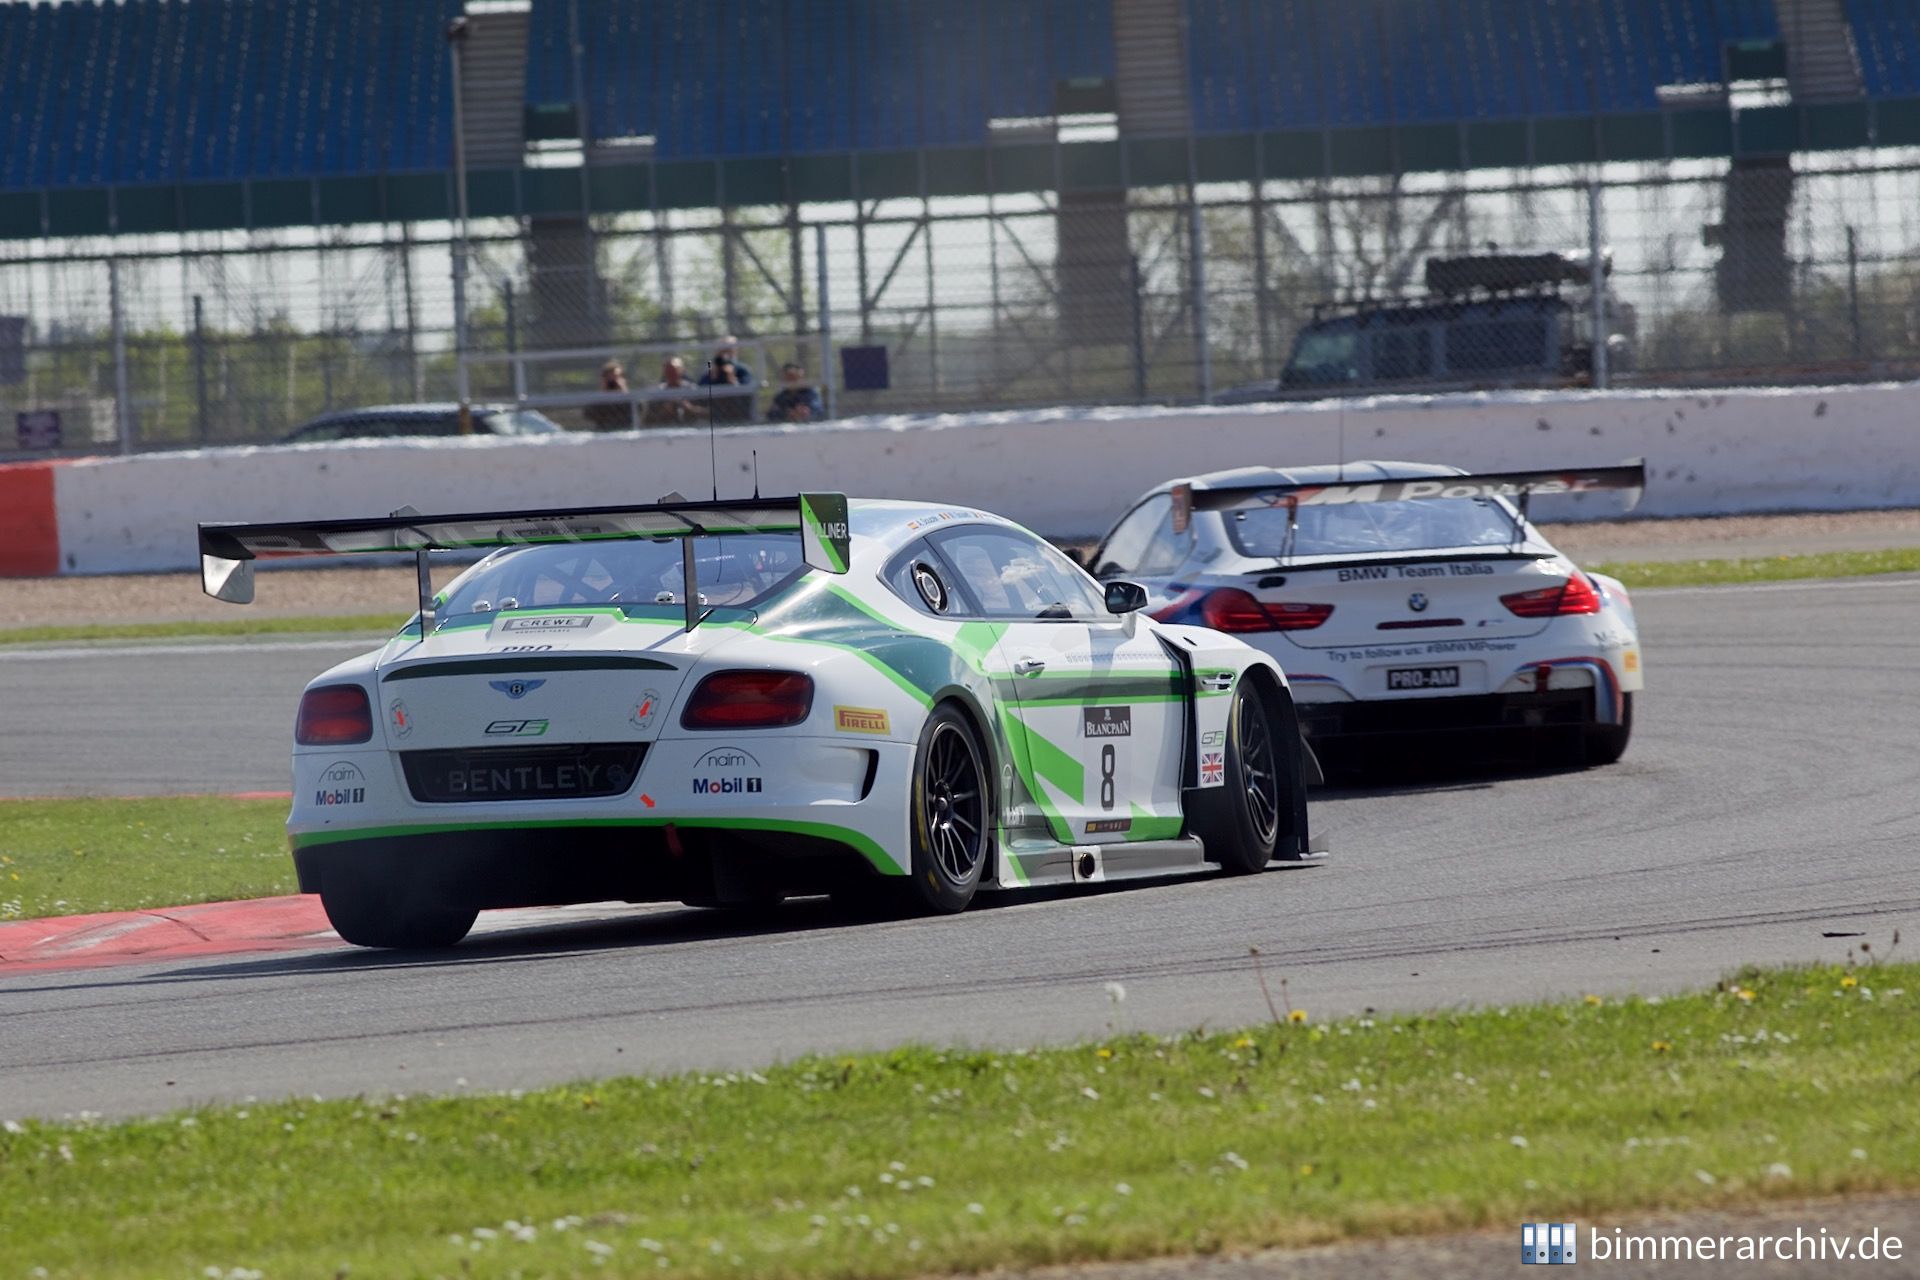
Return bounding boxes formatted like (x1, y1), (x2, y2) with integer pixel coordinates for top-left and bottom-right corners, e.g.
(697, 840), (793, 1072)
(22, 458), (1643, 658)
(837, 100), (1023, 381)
(1217, 253), (1634, 403)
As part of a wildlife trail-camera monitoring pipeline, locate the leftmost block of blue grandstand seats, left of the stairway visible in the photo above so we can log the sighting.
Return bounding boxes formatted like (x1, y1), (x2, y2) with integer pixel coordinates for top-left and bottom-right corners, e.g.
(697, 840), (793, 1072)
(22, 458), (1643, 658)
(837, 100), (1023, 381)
(0, 0), (459, 190)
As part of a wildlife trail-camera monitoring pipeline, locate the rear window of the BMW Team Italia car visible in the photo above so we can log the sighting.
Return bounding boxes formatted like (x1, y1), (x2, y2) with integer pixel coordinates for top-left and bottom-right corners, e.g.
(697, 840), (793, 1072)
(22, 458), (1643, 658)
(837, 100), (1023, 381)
(1221, 497), (1515, 558)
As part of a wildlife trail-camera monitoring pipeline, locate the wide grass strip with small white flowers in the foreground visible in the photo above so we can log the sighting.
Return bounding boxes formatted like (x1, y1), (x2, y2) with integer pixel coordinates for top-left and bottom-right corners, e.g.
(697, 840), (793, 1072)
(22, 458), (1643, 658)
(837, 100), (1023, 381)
(0, 965), (1920, 1280)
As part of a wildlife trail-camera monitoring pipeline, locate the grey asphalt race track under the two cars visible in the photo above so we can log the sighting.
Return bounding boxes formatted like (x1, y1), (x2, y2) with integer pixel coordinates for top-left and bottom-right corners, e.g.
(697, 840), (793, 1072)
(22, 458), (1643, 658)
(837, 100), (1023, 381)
(0, 578), (1920, 1117)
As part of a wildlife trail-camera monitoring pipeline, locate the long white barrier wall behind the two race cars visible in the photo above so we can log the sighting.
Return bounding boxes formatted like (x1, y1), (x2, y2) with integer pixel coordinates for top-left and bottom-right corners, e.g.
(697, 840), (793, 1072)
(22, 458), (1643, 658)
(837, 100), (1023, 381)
(54, 384), (1920, 574)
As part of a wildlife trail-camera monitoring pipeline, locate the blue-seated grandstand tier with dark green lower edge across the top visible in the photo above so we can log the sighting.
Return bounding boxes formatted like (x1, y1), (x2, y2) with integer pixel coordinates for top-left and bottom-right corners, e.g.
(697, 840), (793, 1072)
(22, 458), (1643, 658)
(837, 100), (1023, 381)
(0, 0), (1920, 227)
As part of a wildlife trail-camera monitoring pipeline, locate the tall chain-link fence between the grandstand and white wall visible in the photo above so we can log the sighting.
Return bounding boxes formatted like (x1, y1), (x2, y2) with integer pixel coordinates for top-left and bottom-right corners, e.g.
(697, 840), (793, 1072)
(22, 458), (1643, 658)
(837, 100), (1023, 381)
(0, 152), (1920, 453)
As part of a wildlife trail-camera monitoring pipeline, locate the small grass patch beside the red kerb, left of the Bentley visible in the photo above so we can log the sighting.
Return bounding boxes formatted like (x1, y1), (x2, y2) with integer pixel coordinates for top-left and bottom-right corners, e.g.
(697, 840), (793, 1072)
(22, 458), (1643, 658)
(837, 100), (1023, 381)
(0, 796), (298, 921)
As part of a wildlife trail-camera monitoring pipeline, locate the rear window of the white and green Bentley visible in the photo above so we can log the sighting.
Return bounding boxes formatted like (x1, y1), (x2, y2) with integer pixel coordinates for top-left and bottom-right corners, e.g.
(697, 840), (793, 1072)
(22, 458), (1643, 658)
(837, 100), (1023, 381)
(442, 533), (806, 614)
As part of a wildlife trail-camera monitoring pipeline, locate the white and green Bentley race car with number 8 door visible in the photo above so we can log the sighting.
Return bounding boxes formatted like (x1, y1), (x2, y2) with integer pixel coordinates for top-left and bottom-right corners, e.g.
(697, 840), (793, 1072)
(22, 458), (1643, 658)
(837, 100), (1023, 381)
(200, 493), (1317, 946)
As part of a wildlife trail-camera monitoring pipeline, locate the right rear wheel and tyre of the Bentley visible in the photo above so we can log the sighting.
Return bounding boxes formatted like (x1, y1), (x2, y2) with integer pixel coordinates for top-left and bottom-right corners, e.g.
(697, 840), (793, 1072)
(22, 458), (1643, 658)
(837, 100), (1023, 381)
(899, 702), (993, 915)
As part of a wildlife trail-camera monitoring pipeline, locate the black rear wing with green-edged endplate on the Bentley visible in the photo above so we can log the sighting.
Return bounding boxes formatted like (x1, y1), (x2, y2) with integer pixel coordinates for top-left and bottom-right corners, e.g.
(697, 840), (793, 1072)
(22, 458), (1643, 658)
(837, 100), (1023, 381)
(200, 493), (851, 635)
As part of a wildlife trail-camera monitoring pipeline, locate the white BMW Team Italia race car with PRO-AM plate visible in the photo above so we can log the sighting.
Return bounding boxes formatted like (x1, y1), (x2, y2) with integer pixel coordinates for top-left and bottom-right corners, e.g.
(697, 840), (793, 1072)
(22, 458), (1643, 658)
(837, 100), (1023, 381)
(1091, 462), (1645, 764)
